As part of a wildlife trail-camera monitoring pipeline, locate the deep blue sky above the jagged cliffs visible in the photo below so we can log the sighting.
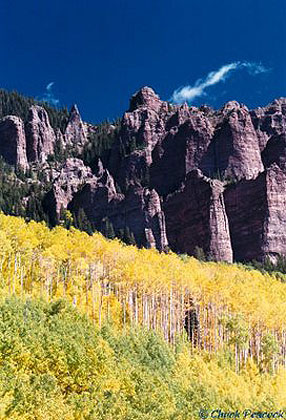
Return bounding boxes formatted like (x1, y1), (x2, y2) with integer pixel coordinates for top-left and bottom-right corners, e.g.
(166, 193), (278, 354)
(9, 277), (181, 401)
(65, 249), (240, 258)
(0, 0), (286, 122)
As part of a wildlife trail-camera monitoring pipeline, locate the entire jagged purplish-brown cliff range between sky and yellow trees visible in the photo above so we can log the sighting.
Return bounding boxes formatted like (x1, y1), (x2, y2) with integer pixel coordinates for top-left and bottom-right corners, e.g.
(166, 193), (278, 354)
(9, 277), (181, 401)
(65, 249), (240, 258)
(0, 87), (286, 262)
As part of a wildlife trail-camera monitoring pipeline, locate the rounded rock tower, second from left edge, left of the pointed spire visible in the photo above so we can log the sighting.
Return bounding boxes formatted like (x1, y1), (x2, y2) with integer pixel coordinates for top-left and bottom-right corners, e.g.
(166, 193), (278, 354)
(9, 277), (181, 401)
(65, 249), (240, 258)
(25, 105), (56, 163)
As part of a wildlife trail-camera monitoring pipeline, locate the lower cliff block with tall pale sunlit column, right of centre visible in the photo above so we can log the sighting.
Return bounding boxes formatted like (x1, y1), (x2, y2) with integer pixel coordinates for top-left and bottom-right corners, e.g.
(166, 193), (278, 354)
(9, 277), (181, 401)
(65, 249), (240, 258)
(163, 170), (232, 262)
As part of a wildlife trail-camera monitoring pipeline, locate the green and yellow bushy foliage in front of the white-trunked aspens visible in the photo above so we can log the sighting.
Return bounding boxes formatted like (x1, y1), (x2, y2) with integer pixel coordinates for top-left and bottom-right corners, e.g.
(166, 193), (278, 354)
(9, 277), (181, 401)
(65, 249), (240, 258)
(0, 297), (286, 420)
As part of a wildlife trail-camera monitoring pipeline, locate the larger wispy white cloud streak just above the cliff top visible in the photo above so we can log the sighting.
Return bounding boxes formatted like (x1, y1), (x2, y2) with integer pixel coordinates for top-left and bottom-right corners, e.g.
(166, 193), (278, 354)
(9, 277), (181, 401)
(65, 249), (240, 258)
(171, 61), (269, 103)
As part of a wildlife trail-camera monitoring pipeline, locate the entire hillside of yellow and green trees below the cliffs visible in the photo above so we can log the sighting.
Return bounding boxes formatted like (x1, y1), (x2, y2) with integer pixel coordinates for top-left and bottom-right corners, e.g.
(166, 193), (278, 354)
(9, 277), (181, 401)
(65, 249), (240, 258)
(0, 214), (286, 420)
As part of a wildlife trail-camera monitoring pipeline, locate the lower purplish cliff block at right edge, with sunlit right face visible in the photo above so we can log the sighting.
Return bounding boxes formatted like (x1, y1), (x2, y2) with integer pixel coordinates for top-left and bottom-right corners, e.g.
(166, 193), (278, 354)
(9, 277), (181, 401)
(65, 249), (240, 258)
(224, 164), (286, 261)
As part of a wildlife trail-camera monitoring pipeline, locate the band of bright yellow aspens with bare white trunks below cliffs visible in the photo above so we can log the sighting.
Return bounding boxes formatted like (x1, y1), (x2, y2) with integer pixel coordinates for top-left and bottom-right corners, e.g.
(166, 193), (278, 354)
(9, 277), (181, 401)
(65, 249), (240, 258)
(0, 214), (286, 372)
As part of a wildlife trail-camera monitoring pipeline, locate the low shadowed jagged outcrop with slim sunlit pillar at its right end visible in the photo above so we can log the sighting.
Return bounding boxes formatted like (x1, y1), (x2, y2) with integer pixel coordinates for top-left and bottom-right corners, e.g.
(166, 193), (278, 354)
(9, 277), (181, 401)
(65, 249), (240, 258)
(69, 176), (168, 250)
